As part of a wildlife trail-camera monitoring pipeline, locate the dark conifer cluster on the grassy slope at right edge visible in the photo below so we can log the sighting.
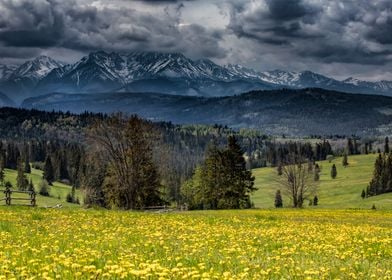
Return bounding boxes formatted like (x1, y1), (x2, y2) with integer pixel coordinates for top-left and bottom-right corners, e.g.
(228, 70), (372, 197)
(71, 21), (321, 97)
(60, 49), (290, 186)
(361, 154), (392, 198)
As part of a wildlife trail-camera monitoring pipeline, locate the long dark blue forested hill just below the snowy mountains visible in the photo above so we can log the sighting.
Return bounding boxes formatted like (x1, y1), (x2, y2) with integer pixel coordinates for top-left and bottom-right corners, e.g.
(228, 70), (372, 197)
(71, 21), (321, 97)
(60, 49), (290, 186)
(23, 88), (392, 136)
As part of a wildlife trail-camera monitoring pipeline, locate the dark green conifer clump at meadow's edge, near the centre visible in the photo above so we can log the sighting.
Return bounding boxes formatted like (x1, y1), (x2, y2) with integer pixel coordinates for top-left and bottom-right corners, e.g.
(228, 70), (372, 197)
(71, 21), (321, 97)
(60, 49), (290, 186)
(181, 137), (256, 209)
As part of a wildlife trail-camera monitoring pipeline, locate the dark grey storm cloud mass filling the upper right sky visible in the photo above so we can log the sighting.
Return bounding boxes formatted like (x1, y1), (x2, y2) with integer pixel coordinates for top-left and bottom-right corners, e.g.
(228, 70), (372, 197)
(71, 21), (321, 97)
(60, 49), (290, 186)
(228, 0), (392, 64)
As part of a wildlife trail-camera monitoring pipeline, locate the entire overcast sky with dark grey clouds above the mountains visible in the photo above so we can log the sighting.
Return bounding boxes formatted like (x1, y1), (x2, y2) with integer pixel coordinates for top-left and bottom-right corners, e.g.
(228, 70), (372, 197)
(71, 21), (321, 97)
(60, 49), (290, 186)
(0, 0), (392, 80)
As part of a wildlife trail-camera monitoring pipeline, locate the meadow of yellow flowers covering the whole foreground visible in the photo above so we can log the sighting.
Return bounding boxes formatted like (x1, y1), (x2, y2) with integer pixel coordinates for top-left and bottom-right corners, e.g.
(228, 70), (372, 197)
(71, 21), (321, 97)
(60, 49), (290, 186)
(0, 207), (392, 279)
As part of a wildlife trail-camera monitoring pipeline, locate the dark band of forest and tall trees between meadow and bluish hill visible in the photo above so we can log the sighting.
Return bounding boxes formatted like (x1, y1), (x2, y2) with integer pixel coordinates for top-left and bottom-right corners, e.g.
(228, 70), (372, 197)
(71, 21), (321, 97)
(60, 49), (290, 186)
(0, 108), (386, 209)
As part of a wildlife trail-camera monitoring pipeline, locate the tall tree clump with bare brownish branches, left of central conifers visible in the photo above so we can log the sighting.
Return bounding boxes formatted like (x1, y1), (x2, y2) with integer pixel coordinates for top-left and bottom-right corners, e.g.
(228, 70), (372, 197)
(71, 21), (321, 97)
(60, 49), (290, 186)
(89, 114), (163, 209)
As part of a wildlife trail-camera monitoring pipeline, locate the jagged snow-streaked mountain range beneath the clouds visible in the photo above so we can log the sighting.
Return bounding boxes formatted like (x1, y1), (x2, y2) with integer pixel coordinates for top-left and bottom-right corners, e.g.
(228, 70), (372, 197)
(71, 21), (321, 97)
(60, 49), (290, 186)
(0, 51), (392, 102)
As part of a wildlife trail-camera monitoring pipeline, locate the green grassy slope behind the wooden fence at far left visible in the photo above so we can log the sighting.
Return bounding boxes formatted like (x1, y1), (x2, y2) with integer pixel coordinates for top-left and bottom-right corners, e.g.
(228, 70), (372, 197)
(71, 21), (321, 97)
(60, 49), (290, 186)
(0, 166), (81, 207)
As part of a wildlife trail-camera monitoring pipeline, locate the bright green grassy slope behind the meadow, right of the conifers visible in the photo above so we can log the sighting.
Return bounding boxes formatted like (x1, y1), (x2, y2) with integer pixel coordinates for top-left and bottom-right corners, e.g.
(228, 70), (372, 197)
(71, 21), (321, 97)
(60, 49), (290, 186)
(253, 154), (392, 209)
